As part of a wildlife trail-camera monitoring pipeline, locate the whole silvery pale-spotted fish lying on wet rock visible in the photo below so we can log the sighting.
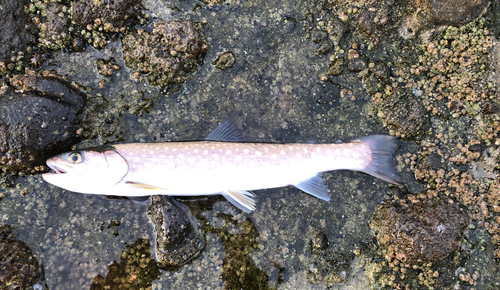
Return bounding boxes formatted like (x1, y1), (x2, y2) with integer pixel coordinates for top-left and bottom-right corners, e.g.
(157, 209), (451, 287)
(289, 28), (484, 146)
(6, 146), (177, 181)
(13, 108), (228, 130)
(42, 119), (403, 212)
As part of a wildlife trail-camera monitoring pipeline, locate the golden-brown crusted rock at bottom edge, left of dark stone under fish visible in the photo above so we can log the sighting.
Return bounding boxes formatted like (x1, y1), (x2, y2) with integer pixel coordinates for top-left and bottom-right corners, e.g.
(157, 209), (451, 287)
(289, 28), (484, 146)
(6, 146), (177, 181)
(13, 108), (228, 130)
(90, 239), (161, 290)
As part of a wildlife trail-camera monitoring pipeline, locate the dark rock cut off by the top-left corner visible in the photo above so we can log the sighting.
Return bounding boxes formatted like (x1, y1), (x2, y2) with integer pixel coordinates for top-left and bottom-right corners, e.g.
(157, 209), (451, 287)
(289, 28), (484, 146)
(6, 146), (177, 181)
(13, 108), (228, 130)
(0, 0), (31, 74)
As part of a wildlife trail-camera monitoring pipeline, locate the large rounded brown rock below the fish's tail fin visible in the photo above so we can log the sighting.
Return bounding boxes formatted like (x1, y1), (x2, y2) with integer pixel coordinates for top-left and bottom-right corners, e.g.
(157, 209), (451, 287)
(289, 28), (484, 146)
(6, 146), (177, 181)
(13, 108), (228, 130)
(370, 200), (468, 263)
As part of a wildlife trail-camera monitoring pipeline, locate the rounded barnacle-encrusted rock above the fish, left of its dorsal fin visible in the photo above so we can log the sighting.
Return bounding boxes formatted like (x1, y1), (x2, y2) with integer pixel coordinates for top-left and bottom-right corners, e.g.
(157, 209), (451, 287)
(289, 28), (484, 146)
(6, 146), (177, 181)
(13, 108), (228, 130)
(122, 21), (208, 86)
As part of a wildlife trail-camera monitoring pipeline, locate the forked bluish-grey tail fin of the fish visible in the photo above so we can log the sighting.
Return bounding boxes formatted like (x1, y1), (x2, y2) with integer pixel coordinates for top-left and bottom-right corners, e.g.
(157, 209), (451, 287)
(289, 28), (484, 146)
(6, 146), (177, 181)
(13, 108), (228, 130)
(358, 135), (403, 186)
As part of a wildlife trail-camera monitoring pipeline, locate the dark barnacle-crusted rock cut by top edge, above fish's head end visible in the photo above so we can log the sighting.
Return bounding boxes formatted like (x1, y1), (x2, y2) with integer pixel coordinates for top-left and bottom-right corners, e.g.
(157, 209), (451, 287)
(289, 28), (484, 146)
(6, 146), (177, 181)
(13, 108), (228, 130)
(72, 0), (139, 31)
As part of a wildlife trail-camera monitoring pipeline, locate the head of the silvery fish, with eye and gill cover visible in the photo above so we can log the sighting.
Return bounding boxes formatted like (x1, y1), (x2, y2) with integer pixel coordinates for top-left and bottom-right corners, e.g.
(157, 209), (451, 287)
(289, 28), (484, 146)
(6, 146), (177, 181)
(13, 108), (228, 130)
(42, 146), (129, 194)
